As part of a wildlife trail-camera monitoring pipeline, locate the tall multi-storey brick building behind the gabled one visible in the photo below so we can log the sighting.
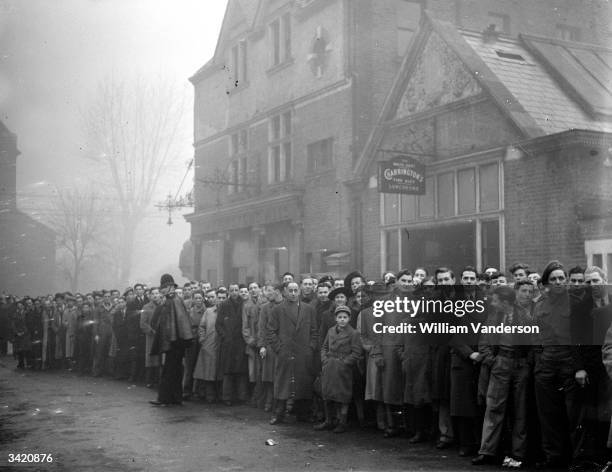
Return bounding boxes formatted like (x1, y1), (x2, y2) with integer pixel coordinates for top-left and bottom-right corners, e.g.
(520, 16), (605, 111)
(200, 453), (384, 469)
(187, 0), (608, 284)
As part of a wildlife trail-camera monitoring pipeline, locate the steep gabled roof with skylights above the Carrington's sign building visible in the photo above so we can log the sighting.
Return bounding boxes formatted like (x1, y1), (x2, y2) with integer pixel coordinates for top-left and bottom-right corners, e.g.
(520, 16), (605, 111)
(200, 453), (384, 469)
(354, 11), (612, 179)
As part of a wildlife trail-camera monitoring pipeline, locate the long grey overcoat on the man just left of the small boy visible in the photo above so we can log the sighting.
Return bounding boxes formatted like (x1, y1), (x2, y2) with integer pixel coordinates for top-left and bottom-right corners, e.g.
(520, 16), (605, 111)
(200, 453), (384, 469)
(267, 300), (318, 400)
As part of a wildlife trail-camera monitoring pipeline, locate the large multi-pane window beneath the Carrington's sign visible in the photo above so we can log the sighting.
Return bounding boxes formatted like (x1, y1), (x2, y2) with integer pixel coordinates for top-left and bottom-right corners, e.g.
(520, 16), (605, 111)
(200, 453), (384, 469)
(381, 162), (504, 270)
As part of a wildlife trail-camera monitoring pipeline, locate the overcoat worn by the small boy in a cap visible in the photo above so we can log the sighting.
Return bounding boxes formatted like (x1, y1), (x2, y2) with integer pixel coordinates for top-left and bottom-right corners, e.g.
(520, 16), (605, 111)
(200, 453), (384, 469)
(321, 324), (362, 403)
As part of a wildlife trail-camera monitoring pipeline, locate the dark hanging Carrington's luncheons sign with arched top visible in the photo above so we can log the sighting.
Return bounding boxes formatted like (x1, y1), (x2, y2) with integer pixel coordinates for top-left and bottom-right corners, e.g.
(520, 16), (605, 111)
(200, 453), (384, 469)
(378, 154), (425, 195)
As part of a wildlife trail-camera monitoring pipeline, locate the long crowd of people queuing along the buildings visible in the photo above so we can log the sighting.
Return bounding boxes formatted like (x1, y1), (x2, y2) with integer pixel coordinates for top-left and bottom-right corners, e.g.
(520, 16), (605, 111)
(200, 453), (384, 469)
(0, 261), (612, 470)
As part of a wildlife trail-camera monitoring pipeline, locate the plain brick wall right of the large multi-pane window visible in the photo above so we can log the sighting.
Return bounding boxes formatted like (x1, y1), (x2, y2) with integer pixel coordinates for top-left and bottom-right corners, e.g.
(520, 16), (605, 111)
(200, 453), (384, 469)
(504, 142), (612, 271)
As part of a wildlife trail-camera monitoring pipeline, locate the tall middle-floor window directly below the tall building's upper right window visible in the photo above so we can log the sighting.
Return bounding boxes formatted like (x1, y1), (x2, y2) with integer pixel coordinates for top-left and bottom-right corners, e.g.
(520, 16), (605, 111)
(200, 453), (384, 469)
(268, 111), (293, 184)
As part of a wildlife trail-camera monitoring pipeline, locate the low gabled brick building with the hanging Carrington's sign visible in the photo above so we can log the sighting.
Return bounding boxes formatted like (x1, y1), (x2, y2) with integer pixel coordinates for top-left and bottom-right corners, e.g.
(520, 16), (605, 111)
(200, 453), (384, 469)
(352, 14), (612, 274)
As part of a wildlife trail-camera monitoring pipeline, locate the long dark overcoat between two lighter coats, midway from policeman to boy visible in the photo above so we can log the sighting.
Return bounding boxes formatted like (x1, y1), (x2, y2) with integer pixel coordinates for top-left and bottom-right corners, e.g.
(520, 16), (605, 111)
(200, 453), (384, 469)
(215, 298), (249, 375)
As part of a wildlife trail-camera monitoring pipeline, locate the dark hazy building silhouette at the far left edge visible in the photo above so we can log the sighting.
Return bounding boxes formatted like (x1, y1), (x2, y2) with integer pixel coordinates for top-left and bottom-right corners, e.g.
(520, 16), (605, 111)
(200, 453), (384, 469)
(0, 121), (55, 295)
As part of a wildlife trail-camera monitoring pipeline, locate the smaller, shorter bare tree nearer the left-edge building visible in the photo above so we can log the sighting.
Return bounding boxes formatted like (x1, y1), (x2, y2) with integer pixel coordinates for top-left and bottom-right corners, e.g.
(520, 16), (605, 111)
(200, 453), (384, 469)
(49, 188), (104, 292)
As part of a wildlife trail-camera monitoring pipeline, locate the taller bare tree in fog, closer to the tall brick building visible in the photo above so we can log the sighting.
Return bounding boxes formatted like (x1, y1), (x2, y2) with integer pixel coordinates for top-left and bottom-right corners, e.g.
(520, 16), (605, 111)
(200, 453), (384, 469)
(85, 75), (186, 283)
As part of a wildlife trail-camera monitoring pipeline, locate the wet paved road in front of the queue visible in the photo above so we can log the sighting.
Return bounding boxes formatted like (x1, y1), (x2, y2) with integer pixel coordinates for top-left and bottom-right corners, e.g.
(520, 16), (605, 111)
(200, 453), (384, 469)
(0, 357), (494, 472)
